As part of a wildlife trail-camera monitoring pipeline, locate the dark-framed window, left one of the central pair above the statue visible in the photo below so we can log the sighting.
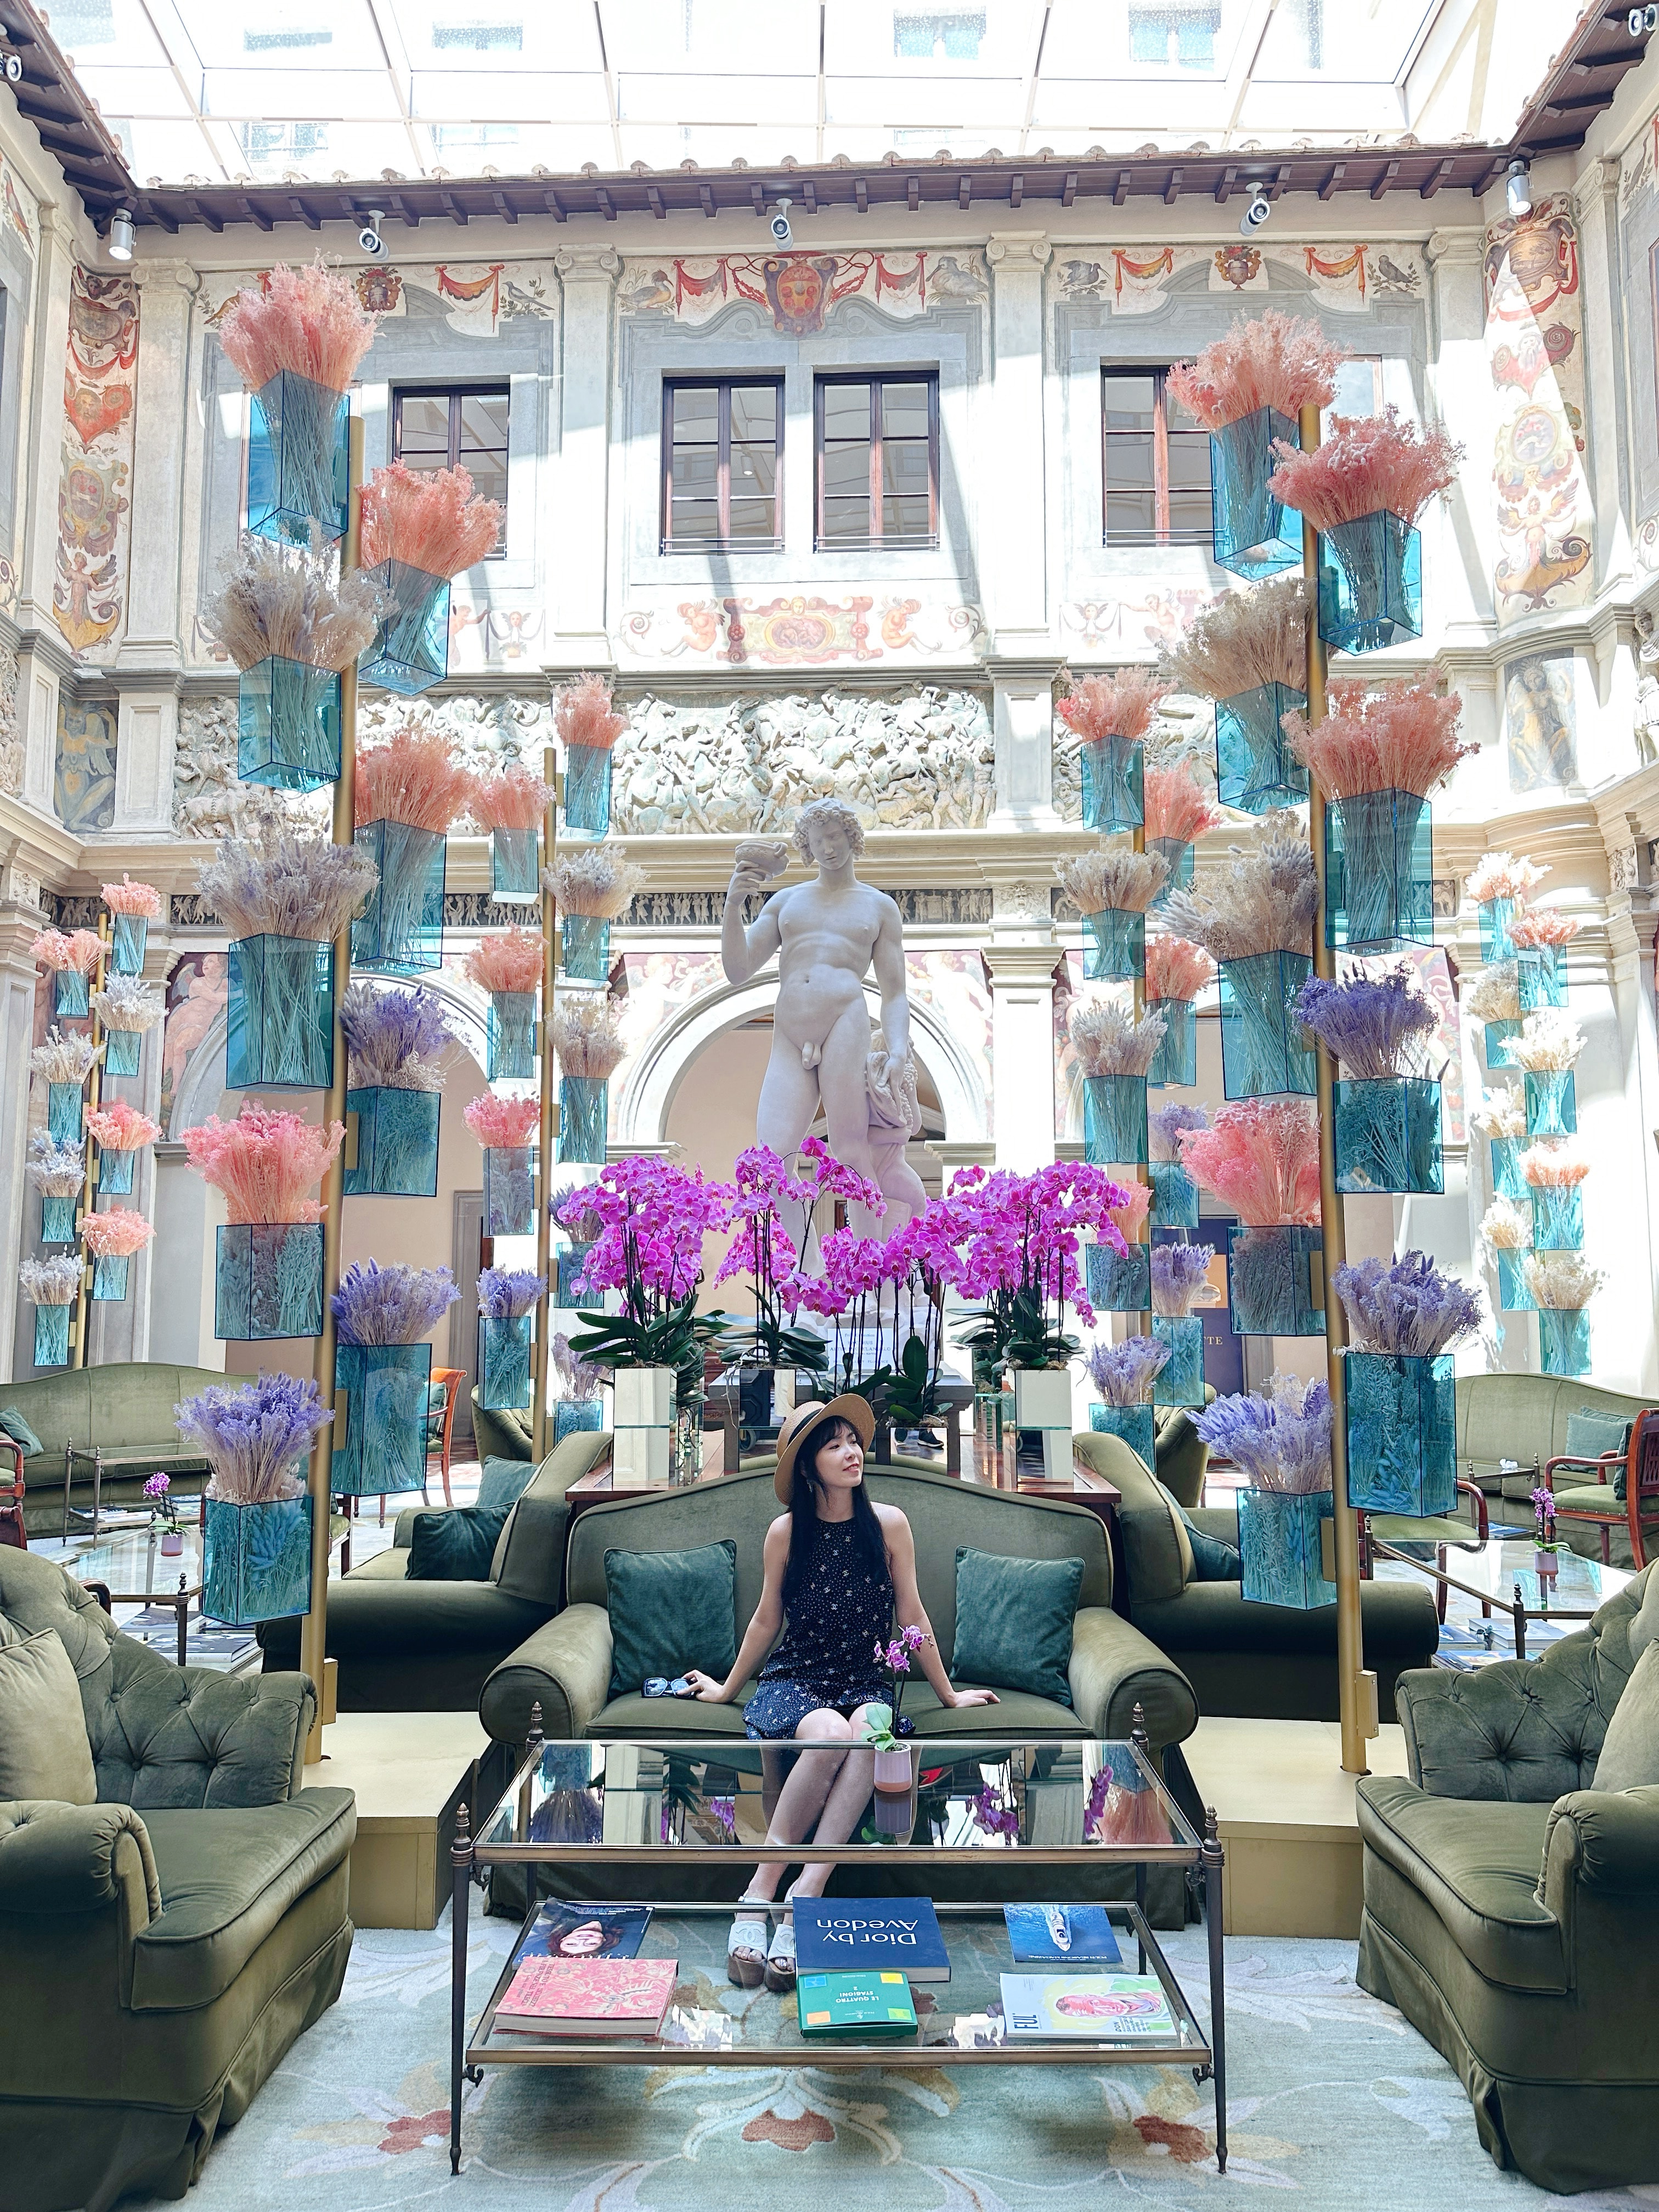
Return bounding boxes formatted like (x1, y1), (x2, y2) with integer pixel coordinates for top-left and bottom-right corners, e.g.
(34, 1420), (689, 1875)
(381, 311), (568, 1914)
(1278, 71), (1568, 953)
(662, 376), (783, 553)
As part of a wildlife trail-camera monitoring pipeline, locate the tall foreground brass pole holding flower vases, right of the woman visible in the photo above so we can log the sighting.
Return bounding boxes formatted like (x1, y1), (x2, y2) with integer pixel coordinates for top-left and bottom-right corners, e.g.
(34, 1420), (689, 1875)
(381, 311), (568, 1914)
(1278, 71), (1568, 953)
(1301, 407), (1376, 1774)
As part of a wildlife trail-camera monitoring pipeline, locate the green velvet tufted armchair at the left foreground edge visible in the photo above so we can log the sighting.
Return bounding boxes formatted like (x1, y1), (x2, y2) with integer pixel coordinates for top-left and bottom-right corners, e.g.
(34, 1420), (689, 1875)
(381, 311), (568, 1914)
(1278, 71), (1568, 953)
(0, 1548), (356, 2212)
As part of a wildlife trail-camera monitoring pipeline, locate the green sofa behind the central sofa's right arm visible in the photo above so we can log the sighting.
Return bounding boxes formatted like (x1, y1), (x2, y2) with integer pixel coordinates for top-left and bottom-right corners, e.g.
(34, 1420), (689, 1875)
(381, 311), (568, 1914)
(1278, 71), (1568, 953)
(1073, 1434), (1440, 1721)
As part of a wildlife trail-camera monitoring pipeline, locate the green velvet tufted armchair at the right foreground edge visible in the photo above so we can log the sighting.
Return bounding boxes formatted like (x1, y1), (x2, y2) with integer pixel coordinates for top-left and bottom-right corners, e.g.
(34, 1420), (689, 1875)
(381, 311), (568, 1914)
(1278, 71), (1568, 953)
(1358, 1566), (1659, 2197)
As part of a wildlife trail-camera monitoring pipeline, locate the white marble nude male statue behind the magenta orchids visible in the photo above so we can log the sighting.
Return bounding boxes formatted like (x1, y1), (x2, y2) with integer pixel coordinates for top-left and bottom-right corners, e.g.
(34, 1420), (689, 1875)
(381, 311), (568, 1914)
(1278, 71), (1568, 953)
(721, 799), (924, 1239)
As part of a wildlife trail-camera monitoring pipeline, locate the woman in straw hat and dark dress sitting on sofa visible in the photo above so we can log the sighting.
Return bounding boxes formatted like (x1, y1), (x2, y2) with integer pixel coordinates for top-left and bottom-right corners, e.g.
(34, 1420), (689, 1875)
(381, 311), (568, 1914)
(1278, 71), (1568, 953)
(686, 1398), (995, 1991)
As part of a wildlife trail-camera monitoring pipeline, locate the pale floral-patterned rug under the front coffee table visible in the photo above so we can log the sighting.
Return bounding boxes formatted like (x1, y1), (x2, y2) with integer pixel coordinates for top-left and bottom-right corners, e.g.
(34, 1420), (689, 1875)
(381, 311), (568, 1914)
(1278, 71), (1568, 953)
(123, 1920), (1659, 2212)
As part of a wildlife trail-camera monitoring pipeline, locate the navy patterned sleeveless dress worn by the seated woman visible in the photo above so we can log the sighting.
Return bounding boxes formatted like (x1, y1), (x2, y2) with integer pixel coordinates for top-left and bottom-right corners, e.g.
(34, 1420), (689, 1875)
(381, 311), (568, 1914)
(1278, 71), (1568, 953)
(743, 1520), (894, 1736)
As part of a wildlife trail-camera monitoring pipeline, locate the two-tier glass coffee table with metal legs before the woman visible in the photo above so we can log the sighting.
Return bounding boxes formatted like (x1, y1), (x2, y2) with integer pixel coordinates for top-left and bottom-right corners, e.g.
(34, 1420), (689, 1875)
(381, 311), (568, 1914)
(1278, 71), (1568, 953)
(449, 1708), (1228, 2172)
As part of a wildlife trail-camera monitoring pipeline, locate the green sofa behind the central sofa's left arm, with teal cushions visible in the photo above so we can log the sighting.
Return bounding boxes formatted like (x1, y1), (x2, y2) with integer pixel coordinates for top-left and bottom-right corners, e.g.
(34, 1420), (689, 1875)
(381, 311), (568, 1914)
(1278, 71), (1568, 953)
(257, 1429), (611, 1712)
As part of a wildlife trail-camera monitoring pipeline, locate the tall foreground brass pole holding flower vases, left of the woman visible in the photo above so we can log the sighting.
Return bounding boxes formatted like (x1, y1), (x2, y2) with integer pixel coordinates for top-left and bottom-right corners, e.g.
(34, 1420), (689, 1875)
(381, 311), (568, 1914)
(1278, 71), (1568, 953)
(298, 407), (363, 1760)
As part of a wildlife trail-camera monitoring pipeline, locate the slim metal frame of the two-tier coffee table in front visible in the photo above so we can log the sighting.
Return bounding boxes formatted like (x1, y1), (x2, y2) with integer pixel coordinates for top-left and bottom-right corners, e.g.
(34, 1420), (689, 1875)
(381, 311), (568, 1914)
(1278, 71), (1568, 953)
(449, 1706), (1228, 2174)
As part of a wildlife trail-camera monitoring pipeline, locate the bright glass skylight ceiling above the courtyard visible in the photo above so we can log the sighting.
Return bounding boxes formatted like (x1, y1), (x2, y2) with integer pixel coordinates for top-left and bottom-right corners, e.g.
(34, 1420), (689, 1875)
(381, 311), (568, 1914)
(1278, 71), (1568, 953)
(51, 0), (1495, 186)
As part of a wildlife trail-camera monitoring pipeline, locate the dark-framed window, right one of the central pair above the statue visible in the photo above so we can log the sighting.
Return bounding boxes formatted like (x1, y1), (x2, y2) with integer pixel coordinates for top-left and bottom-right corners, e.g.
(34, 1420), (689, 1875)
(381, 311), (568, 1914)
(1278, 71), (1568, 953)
(814, 371), (938, 553)
